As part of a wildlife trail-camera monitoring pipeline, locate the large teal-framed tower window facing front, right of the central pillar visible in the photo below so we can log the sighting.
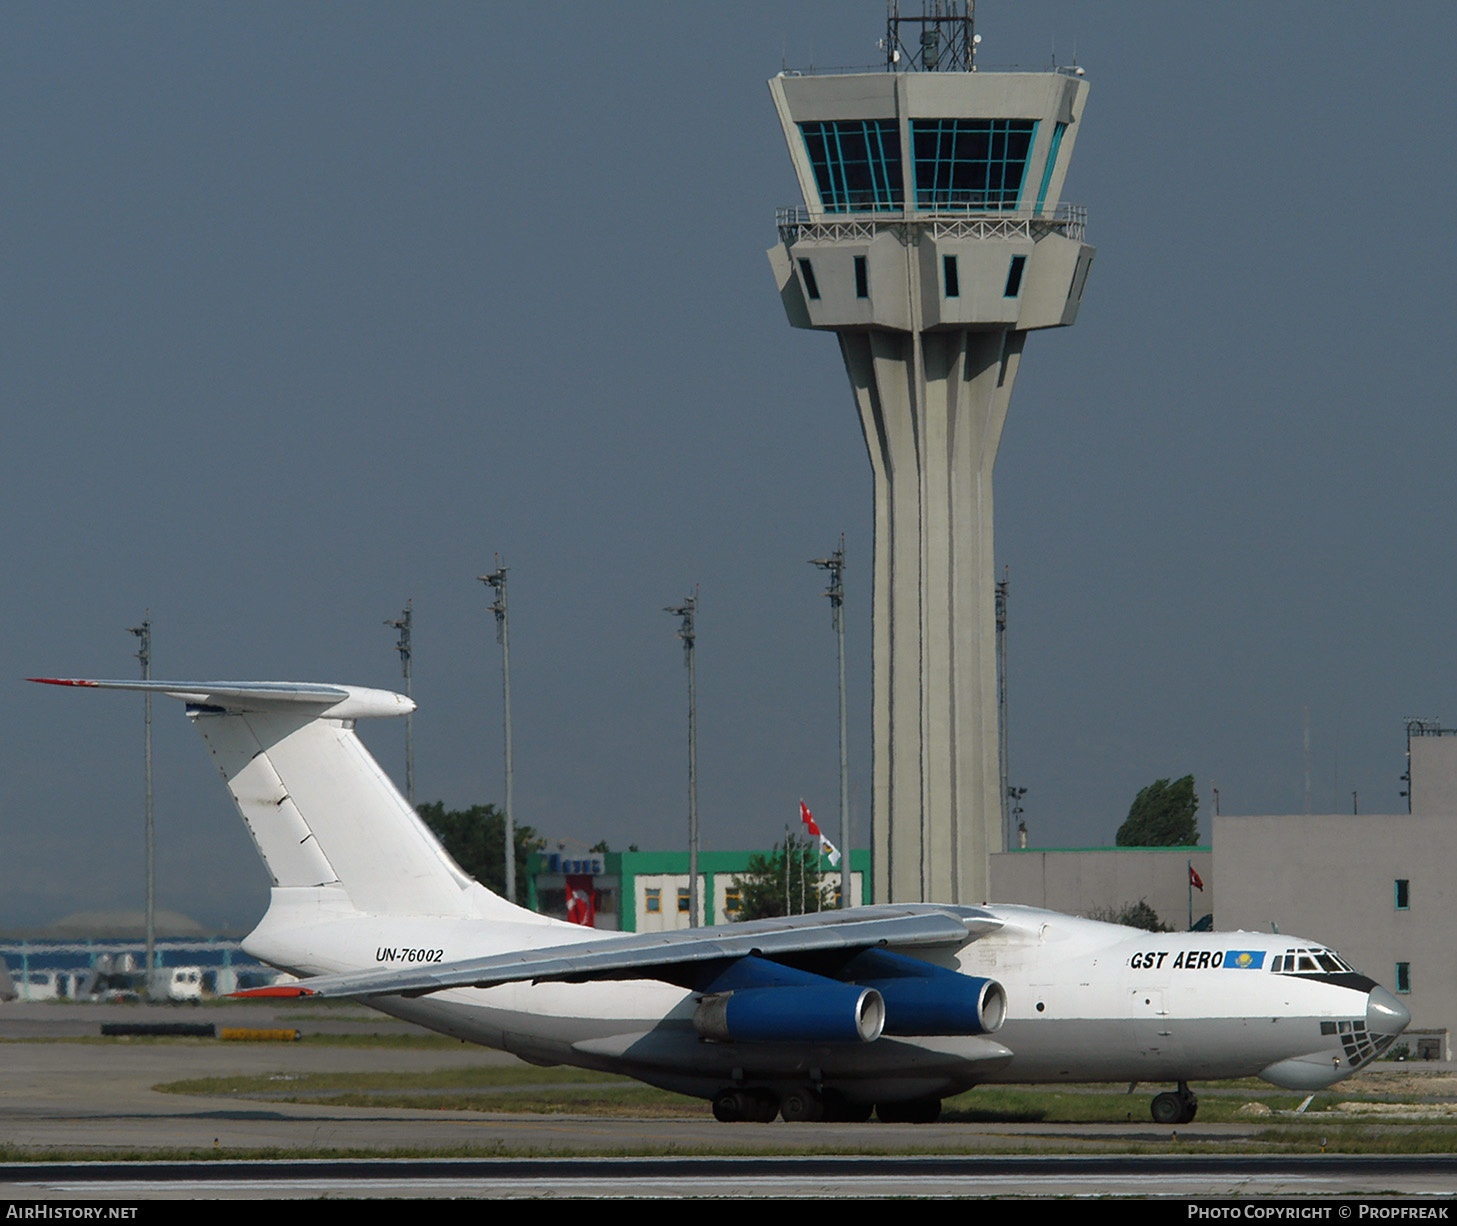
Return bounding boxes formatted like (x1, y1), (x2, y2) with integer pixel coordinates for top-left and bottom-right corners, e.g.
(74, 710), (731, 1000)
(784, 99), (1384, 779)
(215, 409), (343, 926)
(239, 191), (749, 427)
(911, 120), (1037, 210)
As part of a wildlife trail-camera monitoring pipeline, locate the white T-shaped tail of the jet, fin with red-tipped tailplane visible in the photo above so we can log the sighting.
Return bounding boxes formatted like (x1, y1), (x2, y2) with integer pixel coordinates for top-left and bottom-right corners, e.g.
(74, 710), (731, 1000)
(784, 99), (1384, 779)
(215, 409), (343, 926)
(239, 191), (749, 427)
(32, 678), (541, 920)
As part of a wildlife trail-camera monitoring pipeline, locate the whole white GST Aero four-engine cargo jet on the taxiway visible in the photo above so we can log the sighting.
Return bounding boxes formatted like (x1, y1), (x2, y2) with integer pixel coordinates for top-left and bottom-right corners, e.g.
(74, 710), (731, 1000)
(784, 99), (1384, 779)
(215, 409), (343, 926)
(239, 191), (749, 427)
(36, 678), (1409, 1124)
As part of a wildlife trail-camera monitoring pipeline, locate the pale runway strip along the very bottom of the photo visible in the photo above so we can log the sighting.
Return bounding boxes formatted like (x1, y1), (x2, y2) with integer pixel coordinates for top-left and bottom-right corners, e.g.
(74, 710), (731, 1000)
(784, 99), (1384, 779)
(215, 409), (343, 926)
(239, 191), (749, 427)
(8, 1156), (1457, 1201)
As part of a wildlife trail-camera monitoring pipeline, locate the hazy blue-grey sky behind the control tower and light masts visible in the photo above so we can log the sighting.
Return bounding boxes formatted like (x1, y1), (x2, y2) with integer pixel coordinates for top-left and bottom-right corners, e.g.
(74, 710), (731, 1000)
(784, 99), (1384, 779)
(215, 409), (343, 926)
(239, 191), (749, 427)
(0, 0), (1457, 924)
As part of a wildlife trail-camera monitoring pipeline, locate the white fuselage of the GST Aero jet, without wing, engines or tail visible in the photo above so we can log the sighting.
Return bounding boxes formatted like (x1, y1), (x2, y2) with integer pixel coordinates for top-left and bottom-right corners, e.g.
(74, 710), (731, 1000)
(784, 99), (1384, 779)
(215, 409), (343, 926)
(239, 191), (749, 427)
(245, 905), (1406, 1101)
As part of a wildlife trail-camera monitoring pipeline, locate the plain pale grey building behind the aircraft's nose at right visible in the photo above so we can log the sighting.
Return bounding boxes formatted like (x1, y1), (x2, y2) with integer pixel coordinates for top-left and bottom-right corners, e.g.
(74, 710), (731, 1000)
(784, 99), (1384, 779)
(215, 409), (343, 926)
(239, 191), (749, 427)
(991, 723), (1457, 1058)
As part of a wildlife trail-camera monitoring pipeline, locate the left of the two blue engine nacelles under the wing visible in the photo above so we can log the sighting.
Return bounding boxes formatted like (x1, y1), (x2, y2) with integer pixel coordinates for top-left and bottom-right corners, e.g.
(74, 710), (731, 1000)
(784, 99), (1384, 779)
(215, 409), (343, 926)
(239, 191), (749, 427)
(694, 980), (886, 1042)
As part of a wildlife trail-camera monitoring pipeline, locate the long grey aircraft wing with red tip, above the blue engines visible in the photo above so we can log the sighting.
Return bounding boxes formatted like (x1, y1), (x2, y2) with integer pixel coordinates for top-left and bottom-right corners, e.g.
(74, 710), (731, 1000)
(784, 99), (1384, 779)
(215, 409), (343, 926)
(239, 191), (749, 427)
(236, 904), (1002, 997)
